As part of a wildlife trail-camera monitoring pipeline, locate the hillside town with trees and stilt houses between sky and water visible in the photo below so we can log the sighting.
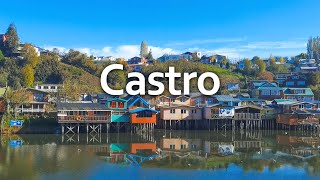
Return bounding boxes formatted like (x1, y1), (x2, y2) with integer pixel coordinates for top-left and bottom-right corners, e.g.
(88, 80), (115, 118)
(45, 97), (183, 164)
(0, 25), (320, 134)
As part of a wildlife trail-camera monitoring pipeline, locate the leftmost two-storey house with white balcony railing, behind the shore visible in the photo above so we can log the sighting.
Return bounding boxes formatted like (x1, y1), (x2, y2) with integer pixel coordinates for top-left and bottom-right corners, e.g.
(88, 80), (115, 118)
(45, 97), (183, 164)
(17, 88), (49, 115)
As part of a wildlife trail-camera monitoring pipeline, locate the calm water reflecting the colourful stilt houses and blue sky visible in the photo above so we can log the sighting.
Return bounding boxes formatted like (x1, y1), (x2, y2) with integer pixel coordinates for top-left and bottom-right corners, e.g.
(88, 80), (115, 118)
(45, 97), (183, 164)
(0, 131), (320, 180)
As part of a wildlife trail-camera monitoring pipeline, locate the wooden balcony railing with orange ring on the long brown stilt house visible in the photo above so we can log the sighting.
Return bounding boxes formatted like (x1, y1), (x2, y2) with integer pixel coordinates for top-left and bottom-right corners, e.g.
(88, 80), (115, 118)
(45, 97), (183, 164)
(58, 116), (111, 123)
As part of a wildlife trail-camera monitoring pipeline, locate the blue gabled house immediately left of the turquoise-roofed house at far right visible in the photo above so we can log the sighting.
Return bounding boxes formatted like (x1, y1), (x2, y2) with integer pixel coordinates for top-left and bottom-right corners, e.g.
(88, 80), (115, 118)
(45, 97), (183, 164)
(250, 81), (283, 100)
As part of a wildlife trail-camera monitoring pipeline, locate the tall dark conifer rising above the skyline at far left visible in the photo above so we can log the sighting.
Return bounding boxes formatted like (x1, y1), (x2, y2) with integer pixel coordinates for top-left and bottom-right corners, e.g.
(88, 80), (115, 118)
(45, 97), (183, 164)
(4, 24), (20, 57)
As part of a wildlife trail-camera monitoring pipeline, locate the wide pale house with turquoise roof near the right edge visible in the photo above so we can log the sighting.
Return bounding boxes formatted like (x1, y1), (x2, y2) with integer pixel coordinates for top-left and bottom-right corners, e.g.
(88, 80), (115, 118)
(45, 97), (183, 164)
(281, 87), (314, 101)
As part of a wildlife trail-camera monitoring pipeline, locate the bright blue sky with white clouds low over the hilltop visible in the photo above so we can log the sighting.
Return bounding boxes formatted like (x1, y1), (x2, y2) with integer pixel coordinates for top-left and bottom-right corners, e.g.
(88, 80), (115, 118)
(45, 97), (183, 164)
(0, 0), (320, 59)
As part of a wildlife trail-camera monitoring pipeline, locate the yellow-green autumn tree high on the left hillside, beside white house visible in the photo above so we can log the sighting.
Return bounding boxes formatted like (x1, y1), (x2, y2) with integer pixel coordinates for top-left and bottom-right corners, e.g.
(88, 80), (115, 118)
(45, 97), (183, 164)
(22, 44), (40, 68)
